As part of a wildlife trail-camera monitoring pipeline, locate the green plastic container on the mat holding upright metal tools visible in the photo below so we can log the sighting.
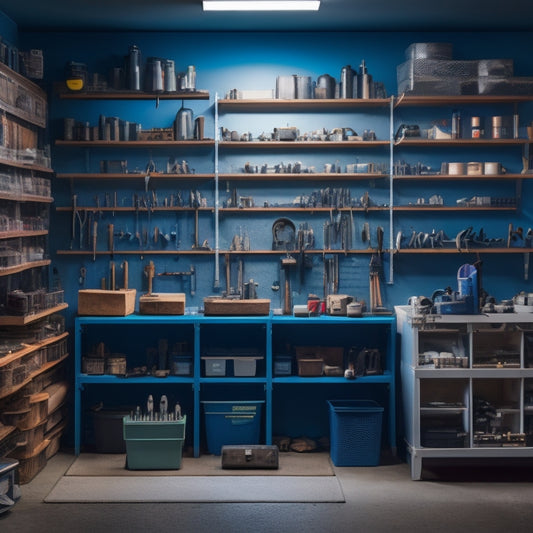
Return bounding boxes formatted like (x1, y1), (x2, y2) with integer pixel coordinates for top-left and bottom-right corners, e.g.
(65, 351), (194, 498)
(124, 416), (187, 470)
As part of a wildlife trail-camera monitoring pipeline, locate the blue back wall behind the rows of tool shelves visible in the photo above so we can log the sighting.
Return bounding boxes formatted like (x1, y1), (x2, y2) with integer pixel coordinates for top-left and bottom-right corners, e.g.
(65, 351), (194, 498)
(15, 32), (533, 322)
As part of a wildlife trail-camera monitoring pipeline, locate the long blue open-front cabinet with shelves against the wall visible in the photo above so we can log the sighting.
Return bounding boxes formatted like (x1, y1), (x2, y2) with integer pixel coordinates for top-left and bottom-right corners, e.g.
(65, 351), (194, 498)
(74, 315), (396, 457)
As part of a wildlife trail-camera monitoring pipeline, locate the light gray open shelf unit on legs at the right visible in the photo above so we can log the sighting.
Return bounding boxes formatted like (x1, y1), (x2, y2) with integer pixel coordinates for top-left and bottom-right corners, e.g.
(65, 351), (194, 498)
(395, 306), (533, 480)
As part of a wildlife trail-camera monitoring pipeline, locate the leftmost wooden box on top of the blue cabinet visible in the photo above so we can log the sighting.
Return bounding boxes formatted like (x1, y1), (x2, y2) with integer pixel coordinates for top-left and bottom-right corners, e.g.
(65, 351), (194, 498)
(78, 289), (137, 316)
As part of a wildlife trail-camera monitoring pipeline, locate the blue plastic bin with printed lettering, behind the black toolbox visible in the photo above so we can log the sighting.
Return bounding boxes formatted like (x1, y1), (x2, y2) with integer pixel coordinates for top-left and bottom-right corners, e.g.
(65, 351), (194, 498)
(201, 400), (265, 455)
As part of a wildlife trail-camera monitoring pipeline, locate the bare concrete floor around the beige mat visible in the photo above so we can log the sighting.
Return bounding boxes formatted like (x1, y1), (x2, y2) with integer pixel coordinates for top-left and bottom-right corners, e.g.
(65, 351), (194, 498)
(0, 453), (533, 533)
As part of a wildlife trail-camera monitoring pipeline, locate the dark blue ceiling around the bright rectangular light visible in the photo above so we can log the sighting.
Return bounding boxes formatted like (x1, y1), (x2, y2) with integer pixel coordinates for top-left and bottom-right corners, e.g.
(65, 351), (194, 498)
(0, 0), (533, 32)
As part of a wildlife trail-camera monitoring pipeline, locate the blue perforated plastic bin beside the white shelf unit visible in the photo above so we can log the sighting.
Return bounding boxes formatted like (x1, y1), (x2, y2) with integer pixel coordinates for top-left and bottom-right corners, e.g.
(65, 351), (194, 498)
(328, 400), (384, 466)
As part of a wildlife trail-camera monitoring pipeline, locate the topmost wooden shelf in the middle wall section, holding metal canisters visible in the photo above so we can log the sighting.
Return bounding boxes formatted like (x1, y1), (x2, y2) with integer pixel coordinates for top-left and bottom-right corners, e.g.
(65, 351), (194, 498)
(218, 98), (390, 113)
